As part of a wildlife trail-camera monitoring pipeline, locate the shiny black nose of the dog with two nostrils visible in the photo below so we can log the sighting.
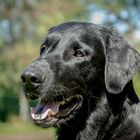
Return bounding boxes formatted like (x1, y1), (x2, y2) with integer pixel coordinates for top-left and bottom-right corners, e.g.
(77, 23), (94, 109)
(21, 69), (44, 87)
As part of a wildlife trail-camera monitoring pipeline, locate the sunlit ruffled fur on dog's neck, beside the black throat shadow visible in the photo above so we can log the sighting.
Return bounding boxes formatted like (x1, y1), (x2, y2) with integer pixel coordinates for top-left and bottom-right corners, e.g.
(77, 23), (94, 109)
(76, 98), (126, 140)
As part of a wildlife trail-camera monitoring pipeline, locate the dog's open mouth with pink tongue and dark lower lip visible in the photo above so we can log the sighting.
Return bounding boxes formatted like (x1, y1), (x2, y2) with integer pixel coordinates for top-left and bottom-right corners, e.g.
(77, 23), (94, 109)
(31, 96), (81, 122)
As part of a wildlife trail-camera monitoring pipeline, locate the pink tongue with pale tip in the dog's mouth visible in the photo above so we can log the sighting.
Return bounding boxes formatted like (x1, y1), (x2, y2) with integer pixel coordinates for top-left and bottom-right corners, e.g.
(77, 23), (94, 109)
(30, 103), (59, 120)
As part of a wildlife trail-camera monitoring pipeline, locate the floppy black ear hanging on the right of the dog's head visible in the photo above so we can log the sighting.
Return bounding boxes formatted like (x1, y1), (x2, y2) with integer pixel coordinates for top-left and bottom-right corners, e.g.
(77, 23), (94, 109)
(105, 29), (140, 94)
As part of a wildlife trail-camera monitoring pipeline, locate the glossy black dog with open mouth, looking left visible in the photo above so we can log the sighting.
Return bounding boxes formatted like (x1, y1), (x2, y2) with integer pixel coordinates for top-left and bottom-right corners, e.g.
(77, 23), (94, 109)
(21, 22), (140, 140)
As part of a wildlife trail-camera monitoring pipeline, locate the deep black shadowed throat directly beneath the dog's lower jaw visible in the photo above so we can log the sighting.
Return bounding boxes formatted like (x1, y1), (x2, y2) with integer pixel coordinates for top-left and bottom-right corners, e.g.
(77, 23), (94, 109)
(57, 99), (88, 140)
